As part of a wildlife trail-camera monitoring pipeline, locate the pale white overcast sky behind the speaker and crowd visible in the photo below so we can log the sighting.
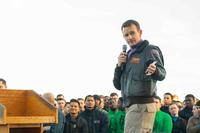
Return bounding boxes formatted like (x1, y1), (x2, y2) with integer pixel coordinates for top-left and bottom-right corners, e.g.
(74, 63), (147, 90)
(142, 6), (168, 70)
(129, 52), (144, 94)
(0, 0), (200, 100)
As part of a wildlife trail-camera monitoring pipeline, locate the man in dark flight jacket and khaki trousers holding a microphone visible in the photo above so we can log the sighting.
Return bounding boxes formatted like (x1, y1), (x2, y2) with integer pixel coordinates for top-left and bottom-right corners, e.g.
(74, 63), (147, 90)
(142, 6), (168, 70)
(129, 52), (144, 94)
(113, 20), (166, 133)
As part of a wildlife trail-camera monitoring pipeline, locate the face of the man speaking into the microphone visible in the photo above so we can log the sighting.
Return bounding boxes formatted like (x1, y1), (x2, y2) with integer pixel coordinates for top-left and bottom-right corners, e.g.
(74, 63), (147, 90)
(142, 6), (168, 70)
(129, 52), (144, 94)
(122, 24), (142, 47)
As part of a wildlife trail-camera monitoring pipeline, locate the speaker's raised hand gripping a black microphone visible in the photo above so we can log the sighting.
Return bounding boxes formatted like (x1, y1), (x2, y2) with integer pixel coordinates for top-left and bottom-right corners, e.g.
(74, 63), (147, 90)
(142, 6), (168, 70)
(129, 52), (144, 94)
(117, 45), (127, 67)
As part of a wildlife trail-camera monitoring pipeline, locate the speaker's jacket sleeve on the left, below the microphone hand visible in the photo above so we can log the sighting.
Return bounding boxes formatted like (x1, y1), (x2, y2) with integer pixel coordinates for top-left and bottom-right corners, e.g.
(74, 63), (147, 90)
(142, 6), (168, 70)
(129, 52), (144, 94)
(113, 66), (122, 90)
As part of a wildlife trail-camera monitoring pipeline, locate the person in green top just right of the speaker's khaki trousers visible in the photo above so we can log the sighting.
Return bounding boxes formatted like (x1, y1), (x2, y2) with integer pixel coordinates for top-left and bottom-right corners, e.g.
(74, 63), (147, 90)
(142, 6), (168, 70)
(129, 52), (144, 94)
(153, 96), (173, 133)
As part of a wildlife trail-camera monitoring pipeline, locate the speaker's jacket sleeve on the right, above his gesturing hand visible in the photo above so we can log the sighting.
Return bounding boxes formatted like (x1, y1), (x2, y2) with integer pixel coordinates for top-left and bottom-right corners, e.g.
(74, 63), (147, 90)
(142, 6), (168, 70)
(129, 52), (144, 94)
(148, 45), (166, 81)
